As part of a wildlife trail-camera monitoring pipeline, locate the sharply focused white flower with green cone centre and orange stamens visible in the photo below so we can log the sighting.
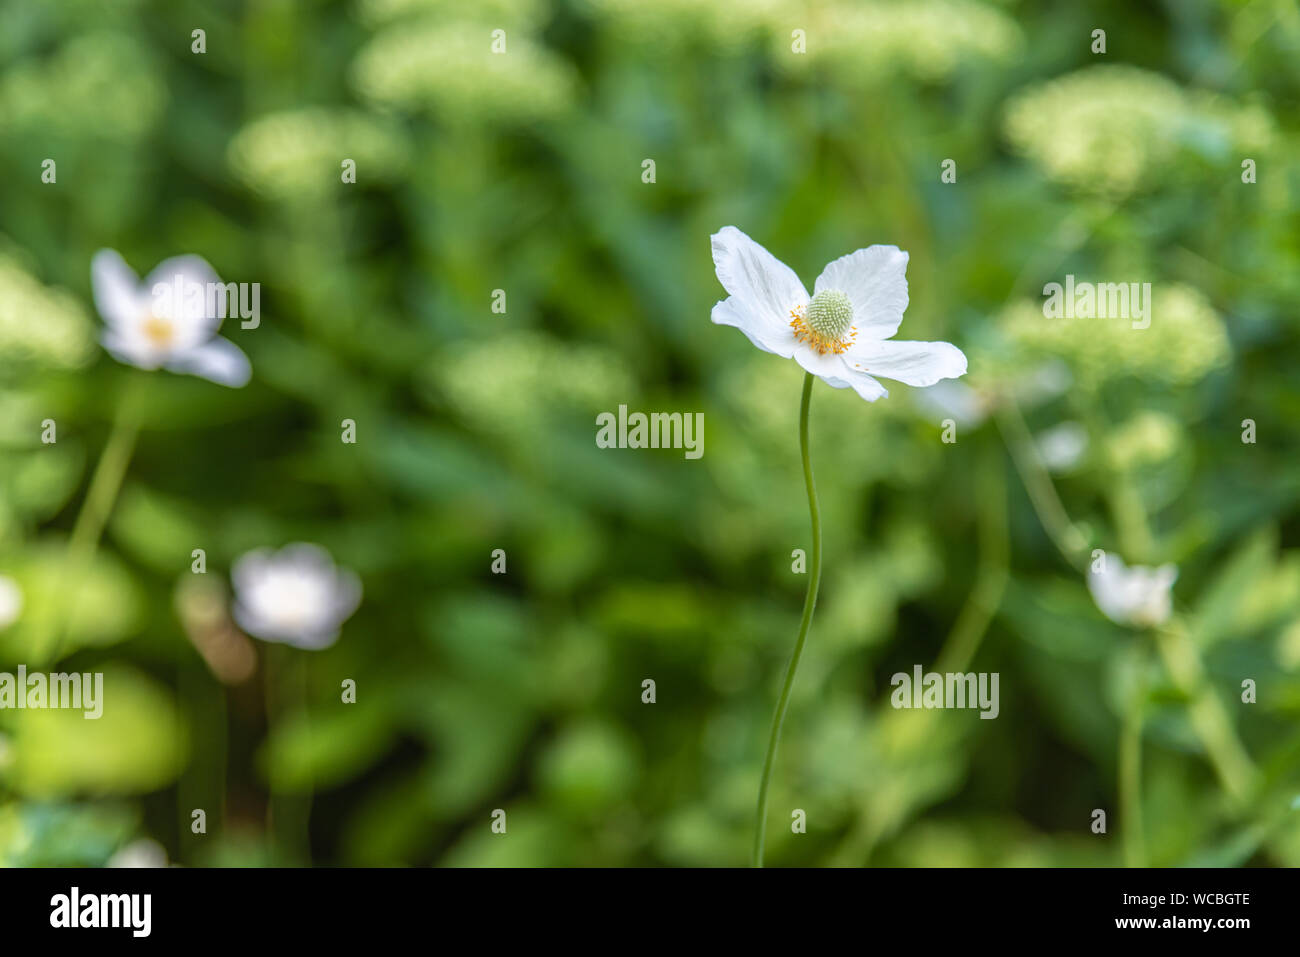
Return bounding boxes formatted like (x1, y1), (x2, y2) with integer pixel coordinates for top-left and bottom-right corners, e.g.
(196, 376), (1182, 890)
(712, 226), (966, 402)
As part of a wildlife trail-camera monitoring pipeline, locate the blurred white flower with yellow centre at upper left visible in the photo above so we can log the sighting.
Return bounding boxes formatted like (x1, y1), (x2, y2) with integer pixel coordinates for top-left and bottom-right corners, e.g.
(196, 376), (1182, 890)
(90, 250), (252, 389)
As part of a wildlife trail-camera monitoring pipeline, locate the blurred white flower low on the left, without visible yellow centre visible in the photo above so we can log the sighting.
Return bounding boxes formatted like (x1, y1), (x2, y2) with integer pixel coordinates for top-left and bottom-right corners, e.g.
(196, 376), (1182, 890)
(230, 542), (361, 650)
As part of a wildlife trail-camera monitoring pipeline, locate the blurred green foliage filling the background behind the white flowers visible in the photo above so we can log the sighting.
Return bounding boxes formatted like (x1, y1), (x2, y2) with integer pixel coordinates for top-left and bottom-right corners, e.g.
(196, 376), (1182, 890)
(0, 0), (1300, 866)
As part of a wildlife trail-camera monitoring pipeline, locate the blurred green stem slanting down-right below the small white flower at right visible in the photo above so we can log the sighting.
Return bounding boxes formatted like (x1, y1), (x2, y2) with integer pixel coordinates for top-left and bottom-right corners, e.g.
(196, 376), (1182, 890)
(1156, 615), (1257, 806)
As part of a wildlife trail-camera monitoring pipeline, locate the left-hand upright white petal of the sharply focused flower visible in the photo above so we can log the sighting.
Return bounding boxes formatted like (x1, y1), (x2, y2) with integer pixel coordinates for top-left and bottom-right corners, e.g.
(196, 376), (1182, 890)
(712, 226), (809, 356)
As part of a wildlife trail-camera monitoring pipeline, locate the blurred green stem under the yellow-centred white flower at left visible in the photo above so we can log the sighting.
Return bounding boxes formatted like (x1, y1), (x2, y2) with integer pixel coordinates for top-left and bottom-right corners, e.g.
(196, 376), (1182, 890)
(42, 373), (147, 661)
